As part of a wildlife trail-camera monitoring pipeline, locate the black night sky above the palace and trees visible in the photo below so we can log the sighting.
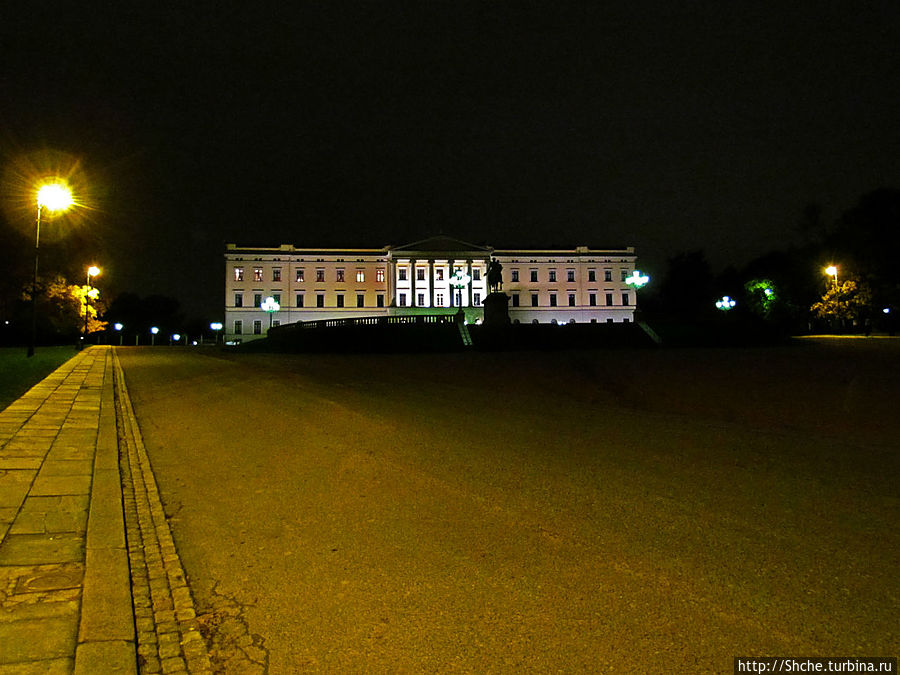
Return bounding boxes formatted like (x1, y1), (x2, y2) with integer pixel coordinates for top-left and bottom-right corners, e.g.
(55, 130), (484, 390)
(0, 0), (900, 316)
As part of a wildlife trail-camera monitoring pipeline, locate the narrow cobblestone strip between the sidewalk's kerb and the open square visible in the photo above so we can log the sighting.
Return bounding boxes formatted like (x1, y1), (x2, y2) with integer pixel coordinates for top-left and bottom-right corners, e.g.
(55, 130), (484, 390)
(113, 350), (212, 674)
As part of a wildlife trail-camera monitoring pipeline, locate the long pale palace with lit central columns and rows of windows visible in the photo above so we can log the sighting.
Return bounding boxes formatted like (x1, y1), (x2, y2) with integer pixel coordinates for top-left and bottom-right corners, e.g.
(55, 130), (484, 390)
(224, 236), (636, 341)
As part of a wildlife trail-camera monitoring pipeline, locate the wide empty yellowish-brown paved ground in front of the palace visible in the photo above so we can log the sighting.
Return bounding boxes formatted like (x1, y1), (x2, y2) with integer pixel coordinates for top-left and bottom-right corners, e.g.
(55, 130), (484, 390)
(118, 339), (900, 673)
